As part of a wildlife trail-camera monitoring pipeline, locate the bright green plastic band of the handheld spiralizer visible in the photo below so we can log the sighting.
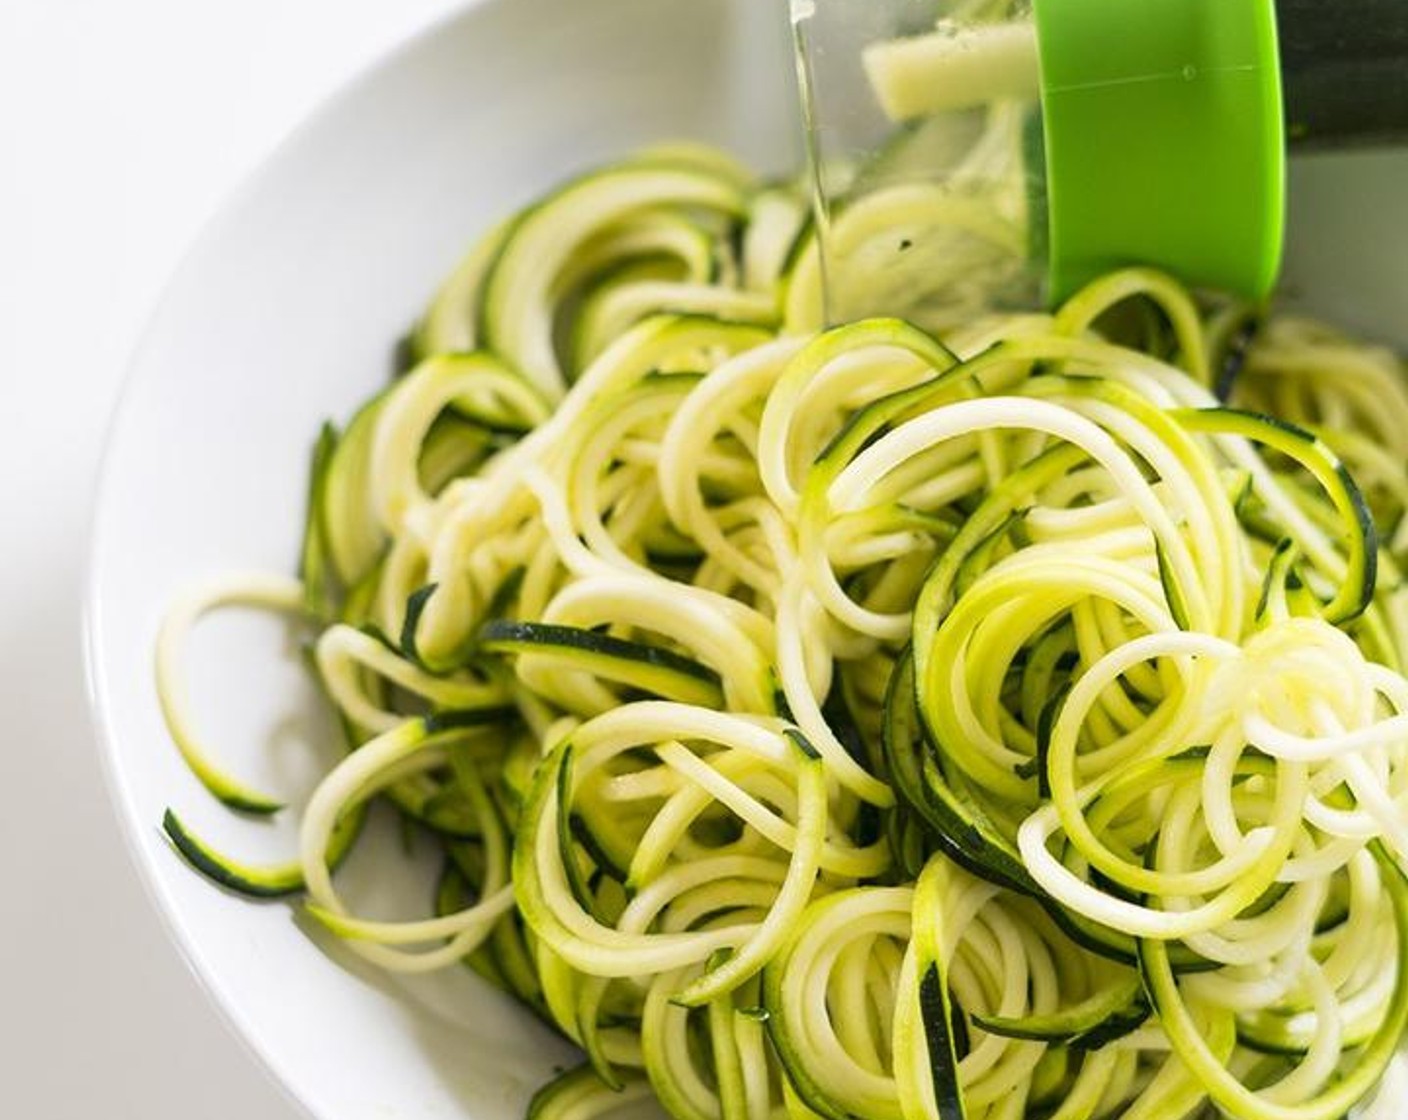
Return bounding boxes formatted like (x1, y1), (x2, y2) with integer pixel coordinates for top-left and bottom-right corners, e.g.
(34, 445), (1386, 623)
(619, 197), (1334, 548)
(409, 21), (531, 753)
(1033, 0), (1286, 300)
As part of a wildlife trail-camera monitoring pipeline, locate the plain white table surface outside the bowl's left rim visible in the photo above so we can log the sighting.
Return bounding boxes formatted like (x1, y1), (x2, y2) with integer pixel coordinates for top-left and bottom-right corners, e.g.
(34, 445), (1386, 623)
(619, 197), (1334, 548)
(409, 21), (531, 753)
(0, 0), (459, 1120)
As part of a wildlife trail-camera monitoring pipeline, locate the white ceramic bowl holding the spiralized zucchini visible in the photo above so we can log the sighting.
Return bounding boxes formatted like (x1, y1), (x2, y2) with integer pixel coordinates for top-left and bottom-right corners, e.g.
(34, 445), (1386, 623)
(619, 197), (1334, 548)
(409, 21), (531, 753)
(89, 0), (1408, 1120)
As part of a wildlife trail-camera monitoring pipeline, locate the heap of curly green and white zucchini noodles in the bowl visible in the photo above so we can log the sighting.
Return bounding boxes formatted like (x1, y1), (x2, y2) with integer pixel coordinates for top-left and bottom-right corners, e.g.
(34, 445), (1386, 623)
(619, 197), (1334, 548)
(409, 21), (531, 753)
(158, 148), (1408, 1120)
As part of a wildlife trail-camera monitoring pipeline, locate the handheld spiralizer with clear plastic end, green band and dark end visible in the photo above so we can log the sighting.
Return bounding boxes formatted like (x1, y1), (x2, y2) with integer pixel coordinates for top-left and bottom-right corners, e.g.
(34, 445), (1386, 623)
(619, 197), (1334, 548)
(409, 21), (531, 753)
(793, 0), (1408, 320)
